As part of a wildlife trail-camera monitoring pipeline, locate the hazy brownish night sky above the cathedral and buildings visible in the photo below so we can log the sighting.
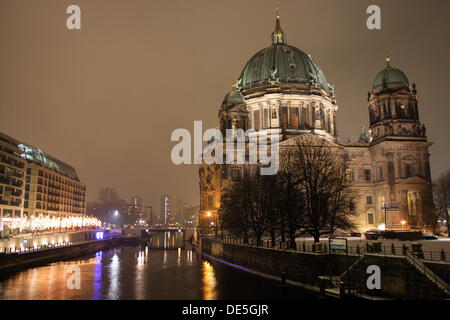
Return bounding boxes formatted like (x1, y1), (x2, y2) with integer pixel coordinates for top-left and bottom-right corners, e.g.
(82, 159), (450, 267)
(0, 0), (450, 210)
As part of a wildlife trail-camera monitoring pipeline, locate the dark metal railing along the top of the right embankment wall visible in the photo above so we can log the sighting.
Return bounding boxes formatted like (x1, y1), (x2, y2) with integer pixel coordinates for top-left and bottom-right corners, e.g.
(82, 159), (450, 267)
(207, 236), (450, 262)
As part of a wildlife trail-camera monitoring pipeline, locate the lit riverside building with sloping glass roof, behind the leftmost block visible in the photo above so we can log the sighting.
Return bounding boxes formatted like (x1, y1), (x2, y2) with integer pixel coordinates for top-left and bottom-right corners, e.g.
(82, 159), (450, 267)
(18, 143), (86, 218)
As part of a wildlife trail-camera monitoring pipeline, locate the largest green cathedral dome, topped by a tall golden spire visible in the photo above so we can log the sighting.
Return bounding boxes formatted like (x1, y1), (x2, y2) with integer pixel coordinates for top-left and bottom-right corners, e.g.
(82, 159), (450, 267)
(237, 7), (331, 93)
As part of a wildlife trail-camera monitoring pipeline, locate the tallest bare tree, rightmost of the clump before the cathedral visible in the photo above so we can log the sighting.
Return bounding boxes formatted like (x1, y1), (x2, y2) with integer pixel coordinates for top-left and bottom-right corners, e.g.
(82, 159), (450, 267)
(284, 135), (355, 242)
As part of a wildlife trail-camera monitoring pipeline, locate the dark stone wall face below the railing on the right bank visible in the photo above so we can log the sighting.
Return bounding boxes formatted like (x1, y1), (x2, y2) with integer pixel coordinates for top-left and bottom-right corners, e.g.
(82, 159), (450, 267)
(201, 238), (450, 299)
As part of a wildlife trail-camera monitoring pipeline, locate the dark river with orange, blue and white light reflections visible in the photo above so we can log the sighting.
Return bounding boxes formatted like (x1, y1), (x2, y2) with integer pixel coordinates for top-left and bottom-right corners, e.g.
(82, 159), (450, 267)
(0, 236), (316, 300)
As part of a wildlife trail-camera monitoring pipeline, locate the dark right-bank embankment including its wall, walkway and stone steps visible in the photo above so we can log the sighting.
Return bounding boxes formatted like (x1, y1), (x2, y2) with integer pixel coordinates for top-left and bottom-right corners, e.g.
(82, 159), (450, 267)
(196, 235), (450, 300)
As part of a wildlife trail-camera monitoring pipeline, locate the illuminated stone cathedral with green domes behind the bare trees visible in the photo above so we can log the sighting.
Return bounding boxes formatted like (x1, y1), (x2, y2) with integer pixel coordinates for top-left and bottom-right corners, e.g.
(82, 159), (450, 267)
(199, 10), (433, 232)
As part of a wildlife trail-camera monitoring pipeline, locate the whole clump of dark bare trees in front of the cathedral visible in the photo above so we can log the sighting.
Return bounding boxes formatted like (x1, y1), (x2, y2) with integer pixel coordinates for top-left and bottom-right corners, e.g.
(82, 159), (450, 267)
(222, 135), (355, 248)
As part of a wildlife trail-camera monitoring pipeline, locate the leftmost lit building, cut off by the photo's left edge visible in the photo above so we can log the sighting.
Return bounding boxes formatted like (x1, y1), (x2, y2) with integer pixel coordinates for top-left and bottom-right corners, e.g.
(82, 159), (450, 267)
(0, 132), (27, 234)
